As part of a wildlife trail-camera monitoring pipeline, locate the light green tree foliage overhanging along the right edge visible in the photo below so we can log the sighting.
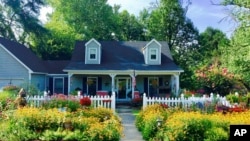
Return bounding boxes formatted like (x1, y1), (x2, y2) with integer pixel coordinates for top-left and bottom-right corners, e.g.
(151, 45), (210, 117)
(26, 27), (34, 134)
(223, 0), (250, 90)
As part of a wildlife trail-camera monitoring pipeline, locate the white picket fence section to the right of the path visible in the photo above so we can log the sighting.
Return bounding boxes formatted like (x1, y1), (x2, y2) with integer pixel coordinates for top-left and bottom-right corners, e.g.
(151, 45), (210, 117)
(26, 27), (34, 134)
(143, 93), (231, 108)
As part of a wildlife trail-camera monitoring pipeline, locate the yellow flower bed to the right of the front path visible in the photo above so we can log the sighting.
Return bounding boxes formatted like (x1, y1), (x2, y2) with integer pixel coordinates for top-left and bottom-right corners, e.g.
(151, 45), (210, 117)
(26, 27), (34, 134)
(136, 104), (250, 141)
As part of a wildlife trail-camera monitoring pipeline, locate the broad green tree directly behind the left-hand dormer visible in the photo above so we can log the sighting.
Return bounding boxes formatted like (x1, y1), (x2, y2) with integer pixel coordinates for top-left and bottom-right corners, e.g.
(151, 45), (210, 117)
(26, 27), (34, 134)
(49, 0), (118, 40)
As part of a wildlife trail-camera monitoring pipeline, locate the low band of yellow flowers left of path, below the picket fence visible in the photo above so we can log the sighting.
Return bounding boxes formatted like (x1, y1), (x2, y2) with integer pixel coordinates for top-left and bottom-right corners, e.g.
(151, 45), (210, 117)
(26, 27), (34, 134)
(0, 107), (122, 141)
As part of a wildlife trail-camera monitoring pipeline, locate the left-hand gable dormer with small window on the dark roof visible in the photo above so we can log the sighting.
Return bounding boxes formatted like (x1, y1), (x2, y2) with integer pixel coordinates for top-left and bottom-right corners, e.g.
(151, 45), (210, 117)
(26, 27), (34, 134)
(85, 39), (101, 64)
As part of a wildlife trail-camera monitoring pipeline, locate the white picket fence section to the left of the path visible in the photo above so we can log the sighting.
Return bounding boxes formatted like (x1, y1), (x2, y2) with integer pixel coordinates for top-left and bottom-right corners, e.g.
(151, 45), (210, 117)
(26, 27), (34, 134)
(26, 93), (115, 111)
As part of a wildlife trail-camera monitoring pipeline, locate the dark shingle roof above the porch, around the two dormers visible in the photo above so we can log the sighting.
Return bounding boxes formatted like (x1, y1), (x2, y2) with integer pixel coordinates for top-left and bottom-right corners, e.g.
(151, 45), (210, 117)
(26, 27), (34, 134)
(64, 41), (182, 71)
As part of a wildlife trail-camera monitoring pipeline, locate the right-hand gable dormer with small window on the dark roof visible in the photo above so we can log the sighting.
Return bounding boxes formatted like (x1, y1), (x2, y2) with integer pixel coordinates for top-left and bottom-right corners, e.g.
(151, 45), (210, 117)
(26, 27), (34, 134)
(143, 39), (161, 65)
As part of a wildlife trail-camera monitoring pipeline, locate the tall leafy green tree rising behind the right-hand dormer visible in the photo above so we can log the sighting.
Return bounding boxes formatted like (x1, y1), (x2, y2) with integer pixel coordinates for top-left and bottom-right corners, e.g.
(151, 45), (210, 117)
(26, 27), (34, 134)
(145, 0), (193, 50)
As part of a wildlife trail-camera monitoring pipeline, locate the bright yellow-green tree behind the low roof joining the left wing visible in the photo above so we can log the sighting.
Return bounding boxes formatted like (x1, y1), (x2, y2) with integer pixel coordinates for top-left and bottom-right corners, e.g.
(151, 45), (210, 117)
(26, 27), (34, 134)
(31, 6), (82, 60)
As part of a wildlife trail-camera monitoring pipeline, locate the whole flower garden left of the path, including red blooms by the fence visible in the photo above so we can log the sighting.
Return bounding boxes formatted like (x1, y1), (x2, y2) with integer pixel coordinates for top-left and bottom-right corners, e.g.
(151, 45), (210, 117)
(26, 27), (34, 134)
(0, 92), (123, 141)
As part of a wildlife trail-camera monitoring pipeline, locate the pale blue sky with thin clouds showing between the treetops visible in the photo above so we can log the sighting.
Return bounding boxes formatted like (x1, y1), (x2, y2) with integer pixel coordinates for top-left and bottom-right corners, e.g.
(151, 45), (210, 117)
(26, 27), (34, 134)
(108, 0), (236, 37)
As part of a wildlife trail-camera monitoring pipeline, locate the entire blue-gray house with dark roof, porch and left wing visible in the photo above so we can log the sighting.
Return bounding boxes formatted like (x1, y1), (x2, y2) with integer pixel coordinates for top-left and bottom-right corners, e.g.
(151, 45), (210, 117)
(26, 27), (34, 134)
(0, 38), (183, 101)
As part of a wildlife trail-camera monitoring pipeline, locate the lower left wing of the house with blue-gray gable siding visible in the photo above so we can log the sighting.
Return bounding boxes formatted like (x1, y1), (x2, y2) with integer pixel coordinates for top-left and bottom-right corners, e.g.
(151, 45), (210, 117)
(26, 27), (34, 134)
(0, 37), (69, 93)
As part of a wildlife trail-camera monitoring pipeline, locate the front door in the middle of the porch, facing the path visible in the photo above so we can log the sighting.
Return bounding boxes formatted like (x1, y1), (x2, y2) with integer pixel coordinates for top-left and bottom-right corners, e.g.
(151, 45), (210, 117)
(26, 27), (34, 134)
(116, 78), (131, 100)
